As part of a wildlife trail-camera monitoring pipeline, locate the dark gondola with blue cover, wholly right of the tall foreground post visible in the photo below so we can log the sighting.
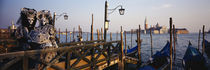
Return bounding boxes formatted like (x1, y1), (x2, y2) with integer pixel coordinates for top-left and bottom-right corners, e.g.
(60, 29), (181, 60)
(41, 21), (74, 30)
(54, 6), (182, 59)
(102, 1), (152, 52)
(182, 42), (207, 70)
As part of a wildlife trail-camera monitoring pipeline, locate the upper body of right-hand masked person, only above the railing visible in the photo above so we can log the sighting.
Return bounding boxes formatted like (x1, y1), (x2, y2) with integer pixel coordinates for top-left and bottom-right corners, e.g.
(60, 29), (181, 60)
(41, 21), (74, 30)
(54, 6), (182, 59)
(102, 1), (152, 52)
(29, 10), (58, 48)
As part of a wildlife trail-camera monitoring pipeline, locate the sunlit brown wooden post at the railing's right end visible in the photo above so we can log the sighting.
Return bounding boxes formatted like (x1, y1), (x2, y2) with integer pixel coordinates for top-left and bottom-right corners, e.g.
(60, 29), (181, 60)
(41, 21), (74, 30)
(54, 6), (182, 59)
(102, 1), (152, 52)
(118, 26), (124, 70)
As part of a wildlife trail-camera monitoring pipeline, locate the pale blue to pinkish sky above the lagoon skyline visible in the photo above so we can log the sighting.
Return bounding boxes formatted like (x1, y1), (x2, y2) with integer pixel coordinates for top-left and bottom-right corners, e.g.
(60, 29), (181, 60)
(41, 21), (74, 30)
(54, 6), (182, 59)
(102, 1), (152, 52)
(0, 0), (210, 33)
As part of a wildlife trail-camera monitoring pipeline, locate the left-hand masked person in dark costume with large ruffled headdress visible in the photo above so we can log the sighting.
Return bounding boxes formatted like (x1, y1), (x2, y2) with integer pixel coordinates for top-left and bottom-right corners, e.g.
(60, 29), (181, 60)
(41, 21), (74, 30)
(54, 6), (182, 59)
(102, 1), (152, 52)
(15, 8), (37, 50)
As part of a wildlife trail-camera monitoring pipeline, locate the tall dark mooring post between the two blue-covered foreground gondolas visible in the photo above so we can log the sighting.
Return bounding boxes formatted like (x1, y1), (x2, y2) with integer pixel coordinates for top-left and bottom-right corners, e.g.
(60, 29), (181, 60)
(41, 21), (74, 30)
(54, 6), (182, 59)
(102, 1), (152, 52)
(169, 17), (172, 70)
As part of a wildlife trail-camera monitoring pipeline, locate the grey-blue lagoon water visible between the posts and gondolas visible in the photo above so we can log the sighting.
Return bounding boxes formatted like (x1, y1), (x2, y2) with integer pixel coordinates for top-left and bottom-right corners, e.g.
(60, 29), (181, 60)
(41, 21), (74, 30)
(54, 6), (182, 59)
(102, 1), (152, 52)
(57, 33), (210, 68)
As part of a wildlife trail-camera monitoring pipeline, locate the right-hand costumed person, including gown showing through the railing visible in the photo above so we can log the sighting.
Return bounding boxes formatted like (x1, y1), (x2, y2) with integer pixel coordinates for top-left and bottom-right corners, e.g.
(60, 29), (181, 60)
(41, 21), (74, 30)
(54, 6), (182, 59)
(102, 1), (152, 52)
(29, 10), (58, 70)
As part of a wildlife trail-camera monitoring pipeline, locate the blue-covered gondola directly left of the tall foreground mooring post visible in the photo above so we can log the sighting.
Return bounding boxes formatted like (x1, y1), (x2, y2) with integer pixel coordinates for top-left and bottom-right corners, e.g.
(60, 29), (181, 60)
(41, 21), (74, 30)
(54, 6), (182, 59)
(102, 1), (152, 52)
(138, 41), (170, 70)
